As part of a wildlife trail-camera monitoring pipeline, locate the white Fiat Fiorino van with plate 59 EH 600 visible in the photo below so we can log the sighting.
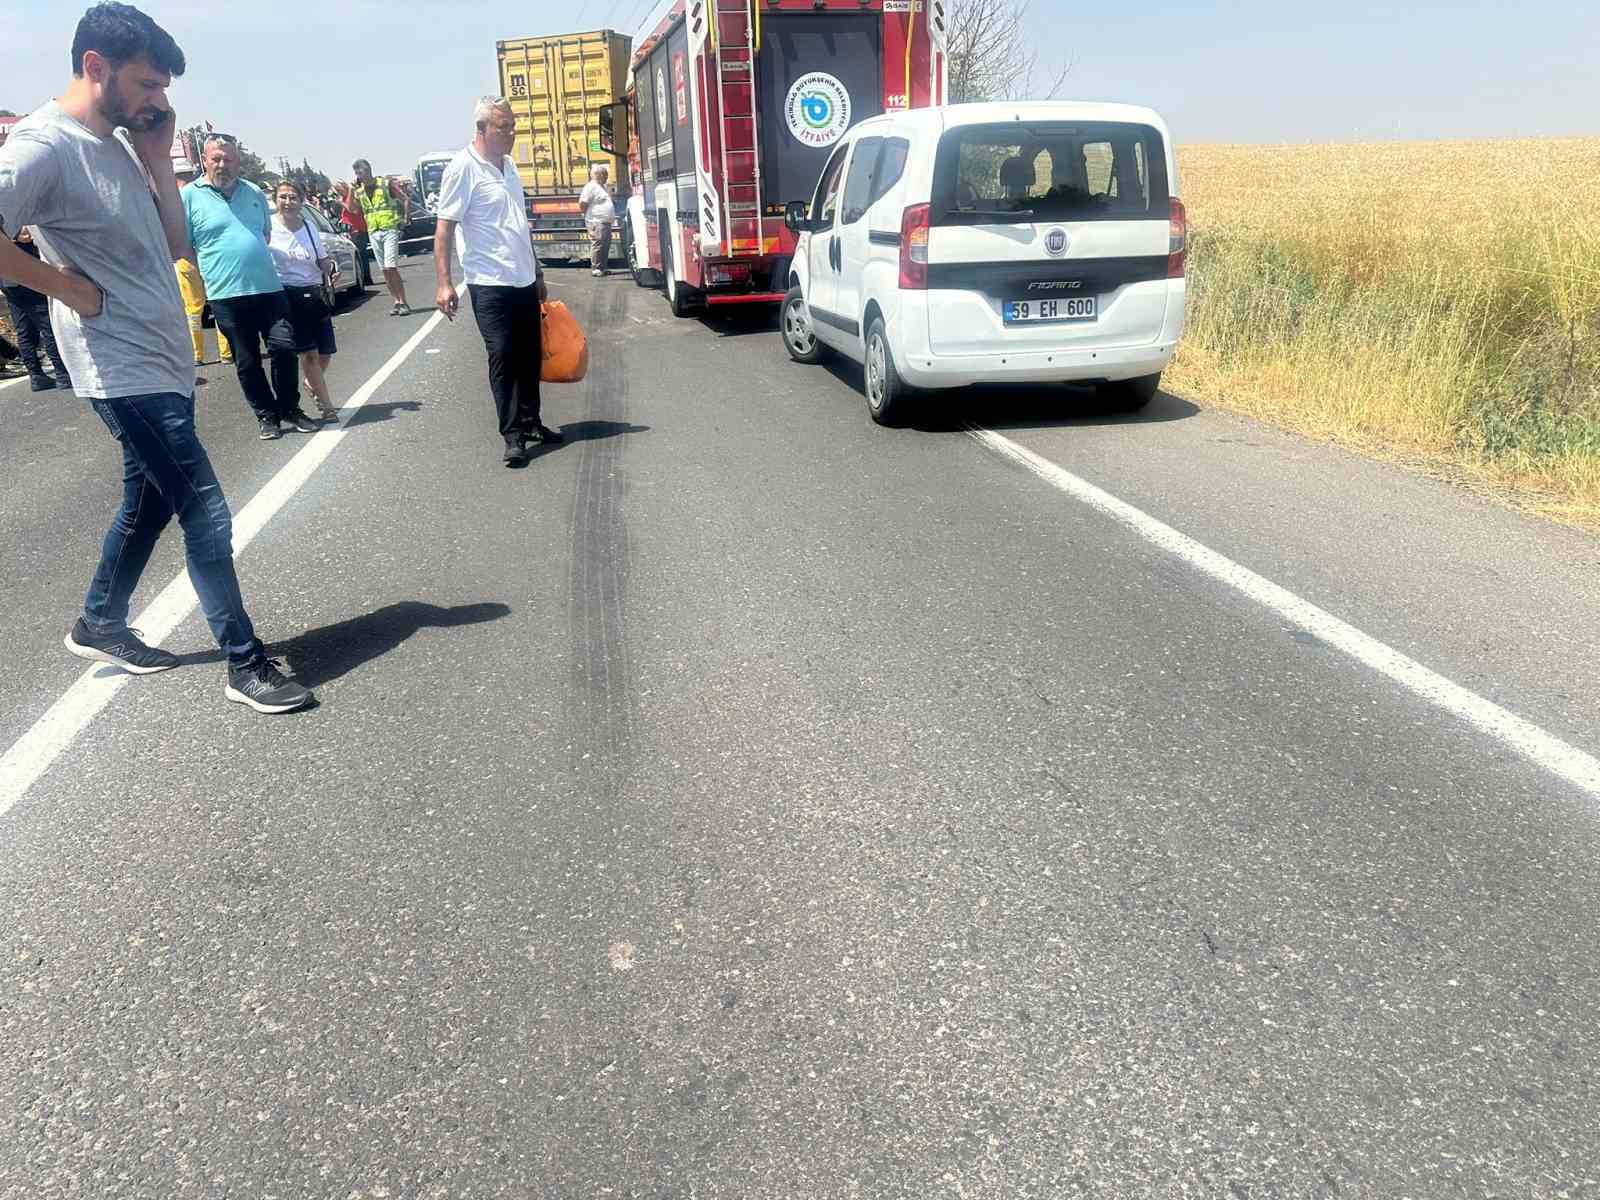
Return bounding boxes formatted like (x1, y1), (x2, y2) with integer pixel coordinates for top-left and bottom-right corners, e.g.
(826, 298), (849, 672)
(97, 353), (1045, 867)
(781, 101), (1187, 424)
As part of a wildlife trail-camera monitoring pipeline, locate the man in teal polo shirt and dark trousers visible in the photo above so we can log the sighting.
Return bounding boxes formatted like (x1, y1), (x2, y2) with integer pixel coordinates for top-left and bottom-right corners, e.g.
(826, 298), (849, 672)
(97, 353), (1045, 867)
(182, 134), (317, 442)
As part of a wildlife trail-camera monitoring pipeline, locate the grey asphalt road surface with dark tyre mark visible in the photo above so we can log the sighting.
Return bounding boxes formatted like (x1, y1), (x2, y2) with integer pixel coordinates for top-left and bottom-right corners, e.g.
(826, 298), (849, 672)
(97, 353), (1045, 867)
(0, 262), (1600, 1200)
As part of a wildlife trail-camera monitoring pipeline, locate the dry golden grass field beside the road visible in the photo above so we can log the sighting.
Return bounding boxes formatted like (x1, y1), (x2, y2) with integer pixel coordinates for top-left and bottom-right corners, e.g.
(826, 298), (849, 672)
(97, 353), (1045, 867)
(1170, 138), (1600, 528)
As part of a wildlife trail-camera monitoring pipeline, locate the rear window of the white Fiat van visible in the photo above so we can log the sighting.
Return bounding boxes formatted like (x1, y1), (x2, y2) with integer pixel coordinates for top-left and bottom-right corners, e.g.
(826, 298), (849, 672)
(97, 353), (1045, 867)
(931, 122), (1168, 226)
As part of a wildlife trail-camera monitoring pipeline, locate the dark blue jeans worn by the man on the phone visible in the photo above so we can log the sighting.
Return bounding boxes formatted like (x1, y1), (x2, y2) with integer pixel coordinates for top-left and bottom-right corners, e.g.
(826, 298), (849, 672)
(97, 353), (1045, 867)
(83, 392), (262, 664)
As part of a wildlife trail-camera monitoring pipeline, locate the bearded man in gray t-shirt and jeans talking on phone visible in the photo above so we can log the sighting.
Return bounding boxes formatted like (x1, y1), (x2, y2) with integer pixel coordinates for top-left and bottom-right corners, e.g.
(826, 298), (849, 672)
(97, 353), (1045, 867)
(0, 3), (312, 712)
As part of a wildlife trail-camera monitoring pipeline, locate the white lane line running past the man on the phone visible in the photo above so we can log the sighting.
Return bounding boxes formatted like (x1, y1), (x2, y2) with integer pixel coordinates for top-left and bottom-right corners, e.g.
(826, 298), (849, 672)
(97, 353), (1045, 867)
(0, 285), (466, 816)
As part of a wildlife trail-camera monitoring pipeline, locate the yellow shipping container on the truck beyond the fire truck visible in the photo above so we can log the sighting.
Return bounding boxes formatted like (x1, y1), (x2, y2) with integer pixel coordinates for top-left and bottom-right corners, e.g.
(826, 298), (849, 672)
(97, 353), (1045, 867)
(496, 29), (634, 197)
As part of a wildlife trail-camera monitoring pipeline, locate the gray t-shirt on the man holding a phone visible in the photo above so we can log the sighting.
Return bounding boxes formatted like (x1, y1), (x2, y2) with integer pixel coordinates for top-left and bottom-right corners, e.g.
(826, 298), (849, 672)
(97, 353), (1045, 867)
(0, 101), (195, 400)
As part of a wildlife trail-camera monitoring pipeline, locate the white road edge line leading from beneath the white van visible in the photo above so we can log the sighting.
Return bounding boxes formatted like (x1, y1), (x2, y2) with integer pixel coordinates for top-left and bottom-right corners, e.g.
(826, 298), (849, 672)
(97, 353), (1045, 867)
(966, 426), (1600, 798)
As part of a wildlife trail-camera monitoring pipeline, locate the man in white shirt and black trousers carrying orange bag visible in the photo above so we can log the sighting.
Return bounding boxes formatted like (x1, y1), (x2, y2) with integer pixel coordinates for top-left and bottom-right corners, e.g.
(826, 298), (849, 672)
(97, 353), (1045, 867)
(434, 96), (563, 467)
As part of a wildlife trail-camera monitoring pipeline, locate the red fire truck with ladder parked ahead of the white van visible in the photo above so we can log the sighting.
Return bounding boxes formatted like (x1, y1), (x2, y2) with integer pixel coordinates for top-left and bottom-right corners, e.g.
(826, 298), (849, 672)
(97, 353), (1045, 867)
(600, 0), (947, 317)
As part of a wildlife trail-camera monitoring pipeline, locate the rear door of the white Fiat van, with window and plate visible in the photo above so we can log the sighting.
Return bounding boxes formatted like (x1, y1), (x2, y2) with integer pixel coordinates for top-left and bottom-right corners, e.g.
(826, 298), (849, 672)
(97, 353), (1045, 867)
(928, 120), (1170, 355)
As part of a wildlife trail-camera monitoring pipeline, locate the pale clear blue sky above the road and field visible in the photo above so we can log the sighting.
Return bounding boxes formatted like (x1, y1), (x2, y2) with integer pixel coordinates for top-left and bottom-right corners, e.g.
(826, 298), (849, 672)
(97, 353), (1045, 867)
(0, 0), (1600, 174)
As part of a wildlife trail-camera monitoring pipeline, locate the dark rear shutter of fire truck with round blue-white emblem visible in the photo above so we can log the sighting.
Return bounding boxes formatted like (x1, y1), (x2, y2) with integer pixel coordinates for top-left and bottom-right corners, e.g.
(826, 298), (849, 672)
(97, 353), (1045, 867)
(757, 11), (883, 213)
